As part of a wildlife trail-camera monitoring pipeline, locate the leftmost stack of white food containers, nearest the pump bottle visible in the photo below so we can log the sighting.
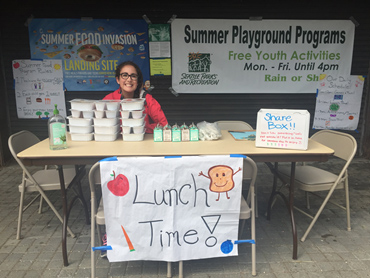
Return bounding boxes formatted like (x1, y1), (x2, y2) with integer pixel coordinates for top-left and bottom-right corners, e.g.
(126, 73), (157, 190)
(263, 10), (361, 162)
(67, 99), (94, 141)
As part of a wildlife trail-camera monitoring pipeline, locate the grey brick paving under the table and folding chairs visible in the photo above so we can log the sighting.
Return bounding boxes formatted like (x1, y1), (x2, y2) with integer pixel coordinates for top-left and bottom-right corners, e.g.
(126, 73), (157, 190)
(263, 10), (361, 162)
(0, 158), (370, 278)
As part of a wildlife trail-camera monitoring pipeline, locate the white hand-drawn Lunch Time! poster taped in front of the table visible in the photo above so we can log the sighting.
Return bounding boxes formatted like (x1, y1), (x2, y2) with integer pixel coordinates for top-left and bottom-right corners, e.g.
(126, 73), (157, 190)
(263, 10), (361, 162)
(100, 156), (243, 262)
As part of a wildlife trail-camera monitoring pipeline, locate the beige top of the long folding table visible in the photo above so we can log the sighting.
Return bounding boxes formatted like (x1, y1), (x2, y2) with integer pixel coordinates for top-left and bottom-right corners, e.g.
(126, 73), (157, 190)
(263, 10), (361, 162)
(18, 130), (334, 165)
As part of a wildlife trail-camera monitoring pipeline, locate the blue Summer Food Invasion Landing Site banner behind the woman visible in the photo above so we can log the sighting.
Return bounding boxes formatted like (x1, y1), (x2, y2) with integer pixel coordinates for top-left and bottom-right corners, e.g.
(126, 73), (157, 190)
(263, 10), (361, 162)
(28, 19), (150, 91)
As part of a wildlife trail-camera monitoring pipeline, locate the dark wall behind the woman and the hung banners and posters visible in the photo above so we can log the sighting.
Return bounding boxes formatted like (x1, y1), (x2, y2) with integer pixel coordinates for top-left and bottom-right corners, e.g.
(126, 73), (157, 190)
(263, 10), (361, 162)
(0, 0), (370, 163)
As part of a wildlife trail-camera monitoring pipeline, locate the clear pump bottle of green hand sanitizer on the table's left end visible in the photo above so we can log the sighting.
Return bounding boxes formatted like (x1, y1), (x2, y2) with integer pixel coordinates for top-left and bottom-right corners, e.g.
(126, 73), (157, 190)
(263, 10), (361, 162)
(48, 104), (67, 150)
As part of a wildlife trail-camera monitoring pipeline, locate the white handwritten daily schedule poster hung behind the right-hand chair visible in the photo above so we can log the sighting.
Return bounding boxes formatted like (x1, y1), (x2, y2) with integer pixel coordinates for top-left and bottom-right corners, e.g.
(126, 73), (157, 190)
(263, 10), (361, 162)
(312, 74), (365, 130)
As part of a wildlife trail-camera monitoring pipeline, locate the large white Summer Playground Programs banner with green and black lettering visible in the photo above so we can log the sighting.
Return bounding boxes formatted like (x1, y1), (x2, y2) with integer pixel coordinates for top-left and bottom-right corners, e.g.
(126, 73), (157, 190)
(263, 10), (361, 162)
(171, 19), (355, 93)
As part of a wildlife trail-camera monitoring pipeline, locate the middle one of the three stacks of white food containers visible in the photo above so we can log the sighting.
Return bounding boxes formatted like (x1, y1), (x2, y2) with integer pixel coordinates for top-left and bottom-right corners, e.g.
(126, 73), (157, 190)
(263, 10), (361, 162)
(93, 100), (120, 141)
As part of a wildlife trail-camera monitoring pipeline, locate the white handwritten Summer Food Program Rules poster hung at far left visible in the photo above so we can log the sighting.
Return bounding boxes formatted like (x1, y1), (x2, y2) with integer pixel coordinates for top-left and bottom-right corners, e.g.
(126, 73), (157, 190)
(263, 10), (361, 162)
(13, 60), (66, 119)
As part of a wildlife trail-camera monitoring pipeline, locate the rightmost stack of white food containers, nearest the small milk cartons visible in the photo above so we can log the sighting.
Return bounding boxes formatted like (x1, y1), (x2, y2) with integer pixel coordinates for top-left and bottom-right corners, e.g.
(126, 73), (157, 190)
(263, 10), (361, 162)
(120, 98), (145, 141)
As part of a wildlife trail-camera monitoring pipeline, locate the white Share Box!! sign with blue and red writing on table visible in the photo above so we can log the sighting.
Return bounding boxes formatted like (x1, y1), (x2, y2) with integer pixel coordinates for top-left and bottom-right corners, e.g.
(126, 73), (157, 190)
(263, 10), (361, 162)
(256, 109), (310, 150)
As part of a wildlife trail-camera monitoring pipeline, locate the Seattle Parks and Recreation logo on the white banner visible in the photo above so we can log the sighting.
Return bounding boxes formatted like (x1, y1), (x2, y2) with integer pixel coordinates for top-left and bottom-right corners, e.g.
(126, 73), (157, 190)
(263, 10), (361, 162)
(179, 52), (220, 85)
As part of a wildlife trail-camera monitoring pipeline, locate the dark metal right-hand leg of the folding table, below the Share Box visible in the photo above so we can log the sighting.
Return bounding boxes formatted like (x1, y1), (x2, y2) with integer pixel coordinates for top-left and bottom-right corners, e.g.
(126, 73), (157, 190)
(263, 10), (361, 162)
(266, 162), (298, 260)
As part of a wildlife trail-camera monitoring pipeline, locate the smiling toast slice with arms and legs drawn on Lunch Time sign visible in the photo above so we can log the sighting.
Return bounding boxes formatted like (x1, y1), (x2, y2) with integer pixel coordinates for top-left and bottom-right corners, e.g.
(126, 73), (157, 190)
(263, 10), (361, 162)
(199, 165), (241, 201)
